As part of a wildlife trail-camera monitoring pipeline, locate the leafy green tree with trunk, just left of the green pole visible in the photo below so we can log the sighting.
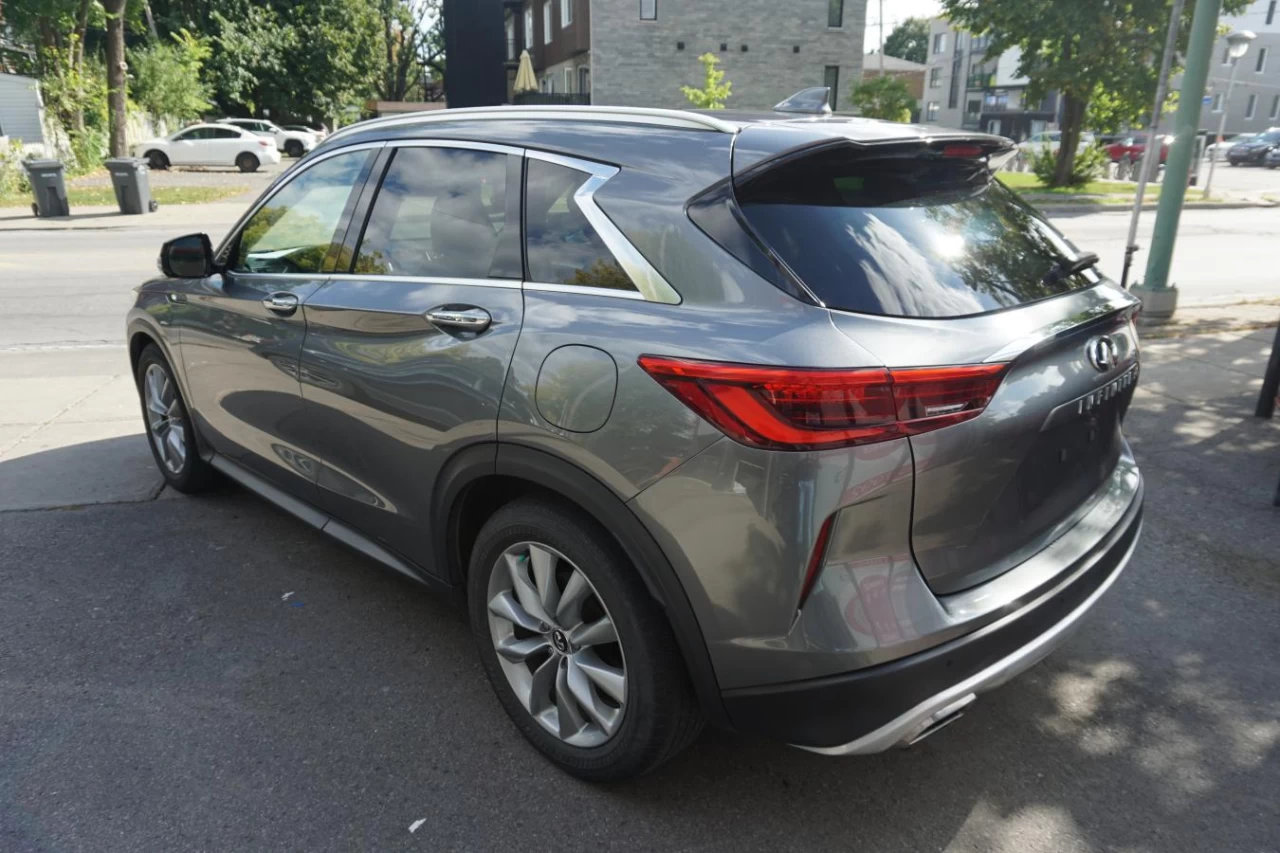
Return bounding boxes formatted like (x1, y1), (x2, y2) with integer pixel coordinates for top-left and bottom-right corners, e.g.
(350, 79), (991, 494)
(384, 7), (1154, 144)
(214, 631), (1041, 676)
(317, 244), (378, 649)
(942, 0), (1249, 186)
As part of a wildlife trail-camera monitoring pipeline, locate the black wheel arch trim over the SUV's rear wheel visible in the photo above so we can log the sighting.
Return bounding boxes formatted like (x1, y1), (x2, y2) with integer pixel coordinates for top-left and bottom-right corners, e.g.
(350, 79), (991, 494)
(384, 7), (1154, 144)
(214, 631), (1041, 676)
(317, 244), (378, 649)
(431, 443), (728, 727)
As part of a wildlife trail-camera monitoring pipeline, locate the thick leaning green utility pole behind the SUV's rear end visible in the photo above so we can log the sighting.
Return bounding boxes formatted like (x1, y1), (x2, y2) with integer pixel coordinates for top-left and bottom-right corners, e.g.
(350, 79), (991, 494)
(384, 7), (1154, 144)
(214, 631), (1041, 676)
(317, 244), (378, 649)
(1133, 0), (1222, 323)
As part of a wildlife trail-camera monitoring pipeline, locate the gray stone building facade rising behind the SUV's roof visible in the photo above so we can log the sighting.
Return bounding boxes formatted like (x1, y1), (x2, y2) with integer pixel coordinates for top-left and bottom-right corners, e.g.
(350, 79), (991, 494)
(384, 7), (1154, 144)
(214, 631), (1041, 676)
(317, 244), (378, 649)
(591, 0), (867, 109)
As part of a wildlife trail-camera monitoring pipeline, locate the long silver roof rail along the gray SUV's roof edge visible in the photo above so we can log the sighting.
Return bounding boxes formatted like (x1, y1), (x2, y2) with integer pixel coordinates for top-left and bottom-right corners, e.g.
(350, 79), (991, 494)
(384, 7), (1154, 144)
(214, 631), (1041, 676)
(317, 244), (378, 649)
(325, 105), (739, 142)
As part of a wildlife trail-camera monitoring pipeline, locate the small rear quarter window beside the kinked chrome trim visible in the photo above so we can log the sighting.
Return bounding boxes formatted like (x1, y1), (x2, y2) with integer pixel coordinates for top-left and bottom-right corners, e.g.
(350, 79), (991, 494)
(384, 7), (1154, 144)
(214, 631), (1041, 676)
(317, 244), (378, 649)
(525, 160), (636, 291)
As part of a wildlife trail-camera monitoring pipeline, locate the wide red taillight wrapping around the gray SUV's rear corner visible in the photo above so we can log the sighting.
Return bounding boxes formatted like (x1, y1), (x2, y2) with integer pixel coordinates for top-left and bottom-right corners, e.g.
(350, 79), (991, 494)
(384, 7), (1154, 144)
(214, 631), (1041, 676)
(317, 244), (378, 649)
(639, 355), (1009, 450)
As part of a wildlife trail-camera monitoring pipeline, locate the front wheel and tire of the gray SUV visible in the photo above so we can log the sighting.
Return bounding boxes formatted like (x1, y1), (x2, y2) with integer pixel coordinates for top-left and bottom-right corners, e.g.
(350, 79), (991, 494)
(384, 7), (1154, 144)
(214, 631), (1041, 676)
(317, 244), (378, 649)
(134, 343), (214, 494)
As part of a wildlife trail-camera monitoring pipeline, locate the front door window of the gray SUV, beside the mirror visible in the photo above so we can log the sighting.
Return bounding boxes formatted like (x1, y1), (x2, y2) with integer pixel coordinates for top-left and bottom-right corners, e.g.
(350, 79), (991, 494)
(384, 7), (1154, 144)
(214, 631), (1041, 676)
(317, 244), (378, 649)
(230, 151), (372, 273)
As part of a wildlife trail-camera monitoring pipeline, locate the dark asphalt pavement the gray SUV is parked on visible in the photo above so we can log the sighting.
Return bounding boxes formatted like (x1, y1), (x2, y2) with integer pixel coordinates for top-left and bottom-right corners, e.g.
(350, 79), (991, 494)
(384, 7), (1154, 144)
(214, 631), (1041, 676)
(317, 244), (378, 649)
(0, 333), (1280, 853)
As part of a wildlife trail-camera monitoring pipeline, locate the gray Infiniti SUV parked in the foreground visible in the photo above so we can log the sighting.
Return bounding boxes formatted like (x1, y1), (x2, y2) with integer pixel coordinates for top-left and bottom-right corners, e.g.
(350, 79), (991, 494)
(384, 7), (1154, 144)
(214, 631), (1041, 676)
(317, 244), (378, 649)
(128, 108), (1143, 780)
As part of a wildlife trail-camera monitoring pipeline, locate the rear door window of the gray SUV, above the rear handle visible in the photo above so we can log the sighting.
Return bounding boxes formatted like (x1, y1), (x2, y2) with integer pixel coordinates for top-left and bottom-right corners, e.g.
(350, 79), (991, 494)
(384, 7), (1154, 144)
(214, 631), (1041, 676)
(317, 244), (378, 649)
(355, 147), (520, 278)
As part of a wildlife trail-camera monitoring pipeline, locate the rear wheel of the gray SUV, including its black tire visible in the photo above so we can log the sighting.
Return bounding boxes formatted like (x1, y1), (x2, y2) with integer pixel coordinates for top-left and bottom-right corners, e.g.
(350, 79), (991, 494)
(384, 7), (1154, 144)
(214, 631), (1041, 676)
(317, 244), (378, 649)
(467, 498), (703, 783)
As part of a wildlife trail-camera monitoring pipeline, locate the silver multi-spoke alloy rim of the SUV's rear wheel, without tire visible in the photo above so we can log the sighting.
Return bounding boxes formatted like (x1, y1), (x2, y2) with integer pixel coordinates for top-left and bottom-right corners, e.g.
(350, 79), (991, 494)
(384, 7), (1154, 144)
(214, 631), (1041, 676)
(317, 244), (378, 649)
(488, 542), (627, 747)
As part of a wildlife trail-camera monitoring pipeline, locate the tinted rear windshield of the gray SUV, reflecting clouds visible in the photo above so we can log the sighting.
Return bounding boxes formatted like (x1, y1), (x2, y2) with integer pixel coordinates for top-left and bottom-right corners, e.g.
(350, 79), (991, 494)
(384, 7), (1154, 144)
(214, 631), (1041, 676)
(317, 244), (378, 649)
(737, 147), (1100, 318)
